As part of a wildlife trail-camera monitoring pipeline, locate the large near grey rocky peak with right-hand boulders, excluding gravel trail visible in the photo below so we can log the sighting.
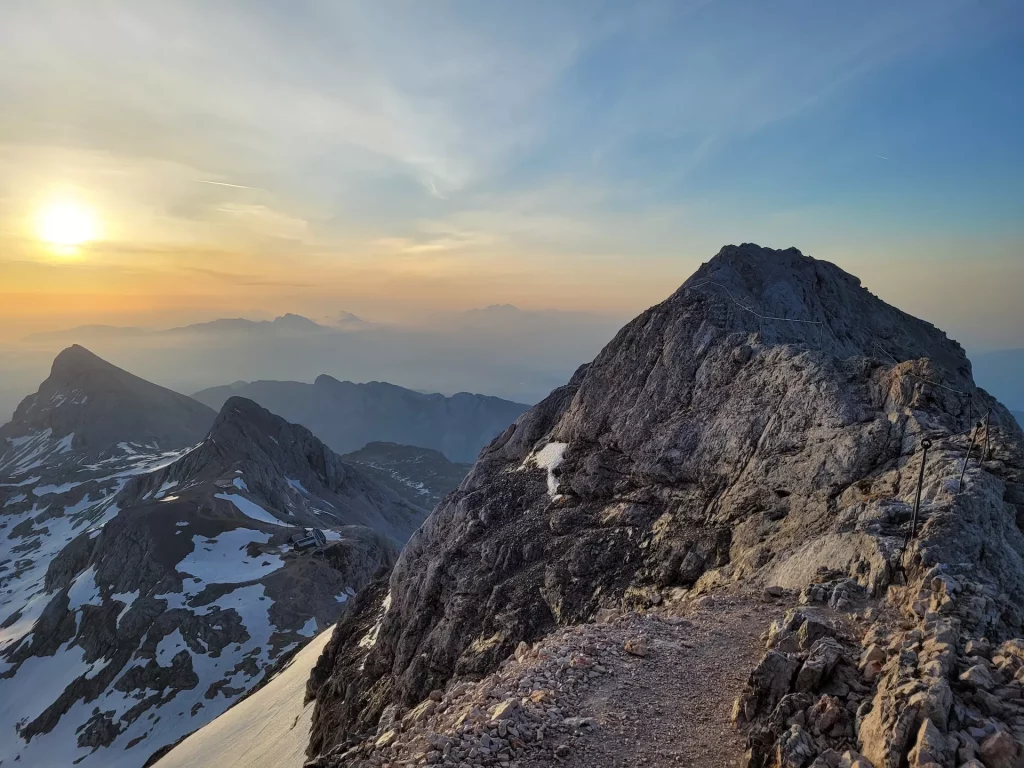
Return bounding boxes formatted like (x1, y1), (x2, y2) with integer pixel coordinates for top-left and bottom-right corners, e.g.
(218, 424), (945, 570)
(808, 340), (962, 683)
(309, 245), (1024, 768)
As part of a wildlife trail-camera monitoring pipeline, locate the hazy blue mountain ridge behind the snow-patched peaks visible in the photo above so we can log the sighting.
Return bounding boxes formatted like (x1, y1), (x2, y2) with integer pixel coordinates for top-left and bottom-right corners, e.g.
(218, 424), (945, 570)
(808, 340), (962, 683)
(193, 375), (527, 462)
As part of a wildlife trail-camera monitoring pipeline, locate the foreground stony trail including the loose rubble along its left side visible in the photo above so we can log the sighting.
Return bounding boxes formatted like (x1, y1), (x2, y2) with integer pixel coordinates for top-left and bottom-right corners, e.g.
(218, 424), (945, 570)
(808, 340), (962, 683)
(303, 590), (796, 768)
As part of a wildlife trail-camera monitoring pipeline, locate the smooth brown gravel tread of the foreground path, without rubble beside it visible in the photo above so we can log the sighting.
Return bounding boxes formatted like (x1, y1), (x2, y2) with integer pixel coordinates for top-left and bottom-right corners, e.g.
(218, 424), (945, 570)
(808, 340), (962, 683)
(522, 597), (780, 768)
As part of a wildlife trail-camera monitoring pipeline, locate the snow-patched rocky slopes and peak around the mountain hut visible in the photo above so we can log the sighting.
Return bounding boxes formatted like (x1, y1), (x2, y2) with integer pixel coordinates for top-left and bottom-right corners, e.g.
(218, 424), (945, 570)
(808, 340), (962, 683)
(0, 352), (426, 768)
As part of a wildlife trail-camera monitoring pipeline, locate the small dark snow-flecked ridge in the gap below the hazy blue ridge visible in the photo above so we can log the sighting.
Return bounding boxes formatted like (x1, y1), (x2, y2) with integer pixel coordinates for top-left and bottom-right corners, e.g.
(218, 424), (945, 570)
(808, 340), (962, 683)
(341, 442), (472, 509)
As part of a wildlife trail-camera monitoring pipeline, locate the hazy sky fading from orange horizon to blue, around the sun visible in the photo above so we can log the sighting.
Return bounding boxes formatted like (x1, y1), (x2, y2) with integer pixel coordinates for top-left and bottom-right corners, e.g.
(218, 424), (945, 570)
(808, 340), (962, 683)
(0, 0), (1024, 349)
